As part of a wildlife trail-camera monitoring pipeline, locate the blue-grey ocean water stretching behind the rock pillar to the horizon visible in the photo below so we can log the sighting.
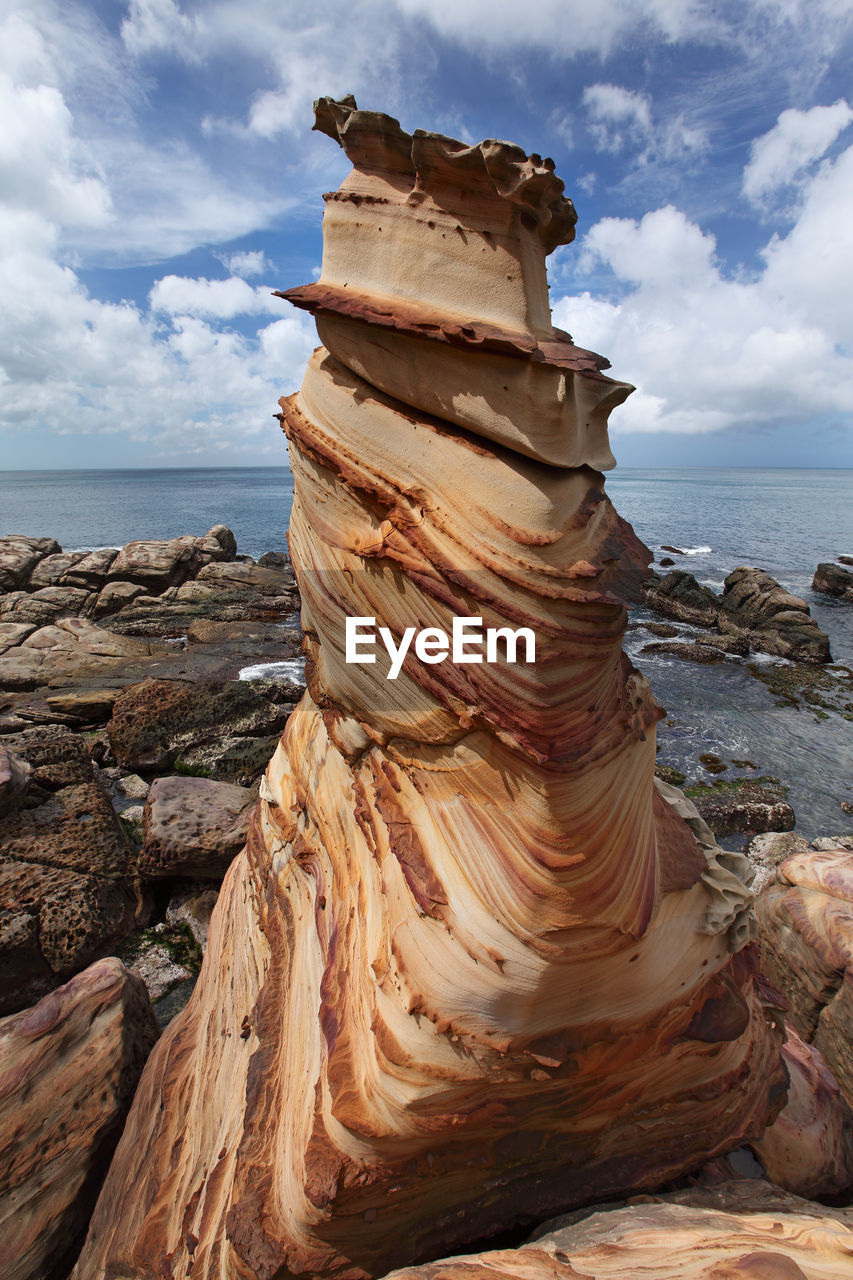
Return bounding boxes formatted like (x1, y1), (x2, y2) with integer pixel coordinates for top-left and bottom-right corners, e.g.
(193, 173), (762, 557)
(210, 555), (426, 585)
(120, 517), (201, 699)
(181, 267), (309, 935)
(0, 466), (853, 838)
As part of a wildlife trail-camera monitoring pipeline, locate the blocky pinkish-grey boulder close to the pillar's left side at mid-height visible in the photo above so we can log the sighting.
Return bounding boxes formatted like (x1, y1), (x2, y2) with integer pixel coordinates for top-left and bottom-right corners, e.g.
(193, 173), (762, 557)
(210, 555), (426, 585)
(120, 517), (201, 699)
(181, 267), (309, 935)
(140, 777), (256, 879)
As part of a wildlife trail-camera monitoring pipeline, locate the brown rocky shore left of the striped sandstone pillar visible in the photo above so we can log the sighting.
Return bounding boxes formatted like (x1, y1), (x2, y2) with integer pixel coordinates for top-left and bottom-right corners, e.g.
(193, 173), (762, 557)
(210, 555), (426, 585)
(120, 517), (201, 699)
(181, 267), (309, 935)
(0, 525), (301, 1023)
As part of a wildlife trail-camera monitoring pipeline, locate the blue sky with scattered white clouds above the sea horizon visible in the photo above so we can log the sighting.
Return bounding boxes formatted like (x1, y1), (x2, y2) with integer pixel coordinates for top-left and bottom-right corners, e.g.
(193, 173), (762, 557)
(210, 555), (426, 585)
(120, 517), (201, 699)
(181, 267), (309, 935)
(0, 0), (853, 470)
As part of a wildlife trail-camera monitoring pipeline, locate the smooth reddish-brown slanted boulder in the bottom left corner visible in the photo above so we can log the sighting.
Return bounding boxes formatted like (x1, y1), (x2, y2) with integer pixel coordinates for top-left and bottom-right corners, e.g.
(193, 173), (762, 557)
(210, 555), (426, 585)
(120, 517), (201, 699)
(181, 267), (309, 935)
(0, 959), (158, 1280)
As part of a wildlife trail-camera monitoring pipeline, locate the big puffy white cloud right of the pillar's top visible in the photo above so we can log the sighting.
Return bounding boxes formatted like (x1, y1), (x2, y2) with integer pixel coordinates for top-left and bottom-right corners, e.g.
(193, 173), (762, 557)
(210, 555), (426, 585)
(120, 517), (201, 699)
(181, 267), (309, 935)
(553, 147), (853, 434)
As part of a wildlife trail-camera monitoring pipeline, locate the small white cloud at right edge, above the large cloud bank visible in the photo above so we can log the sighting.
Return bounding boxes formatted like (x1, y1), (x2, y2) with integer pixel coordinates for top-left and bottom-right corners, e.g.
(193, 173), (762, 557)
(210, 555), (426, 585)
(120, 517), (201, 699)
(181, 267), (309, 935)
(743, 99), (853, 204)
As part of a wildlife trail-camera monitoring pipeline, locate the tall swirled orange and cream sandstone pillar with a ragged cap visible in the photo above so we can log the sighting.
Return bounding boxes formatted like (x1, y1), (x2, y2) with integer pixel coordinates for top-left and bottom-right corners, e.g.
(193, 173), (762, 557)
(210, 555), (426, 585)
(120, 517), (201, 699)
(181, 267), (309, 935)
(76, 100), (785, 1280)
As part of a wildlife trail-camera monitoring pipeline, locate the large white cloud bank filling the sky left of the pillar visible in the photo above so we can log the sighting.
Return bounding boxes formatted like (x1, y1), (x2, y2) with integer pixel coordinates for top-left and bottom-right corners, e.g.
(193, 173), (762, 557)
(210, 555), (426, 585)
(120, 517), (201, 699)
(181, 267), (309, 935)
(0, 4), (315, 456)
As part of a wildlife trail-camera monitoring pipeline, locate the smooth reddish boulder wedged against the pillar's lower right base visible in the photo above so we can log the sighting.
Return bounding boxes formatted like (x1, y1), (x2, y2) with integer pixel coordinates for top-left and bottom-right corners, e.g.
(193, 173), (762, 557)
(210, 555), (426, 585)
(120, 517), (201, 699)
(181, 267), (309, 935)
(752, 1028), (853, 1199)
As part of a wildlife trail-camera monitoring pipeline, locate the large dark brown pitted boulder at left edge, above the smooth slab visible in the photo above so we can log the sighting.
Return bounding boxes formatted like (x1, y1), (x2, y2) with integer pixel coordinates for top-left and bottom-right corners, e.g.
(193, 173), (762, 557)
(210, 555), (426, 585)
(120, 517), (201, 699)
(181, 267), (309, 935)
(0, 726), (142, 1014)
